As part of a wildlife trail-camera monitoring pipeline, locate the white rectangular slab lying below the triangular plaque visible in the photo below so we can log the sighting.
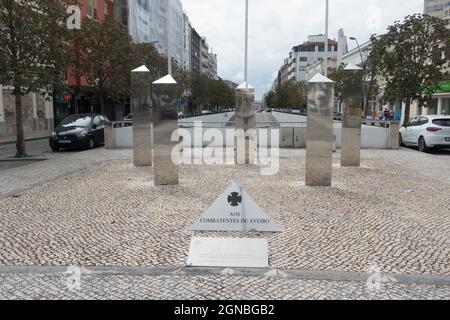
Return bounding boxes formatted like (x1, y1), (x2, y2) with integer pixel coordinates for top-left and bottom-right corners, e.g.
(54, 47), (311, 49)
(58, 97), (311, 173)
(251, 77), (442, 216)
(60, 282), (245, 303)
(187, 238), (269, 268)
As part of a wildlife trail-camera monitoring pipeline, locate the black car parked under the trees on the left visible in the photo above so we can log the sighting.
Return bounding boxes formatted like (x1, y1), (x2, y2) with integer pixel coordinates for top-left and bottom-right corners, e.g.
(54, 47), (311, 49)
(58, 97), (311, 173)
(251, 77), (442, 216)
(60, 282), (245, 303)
(49, 114), (108, 151)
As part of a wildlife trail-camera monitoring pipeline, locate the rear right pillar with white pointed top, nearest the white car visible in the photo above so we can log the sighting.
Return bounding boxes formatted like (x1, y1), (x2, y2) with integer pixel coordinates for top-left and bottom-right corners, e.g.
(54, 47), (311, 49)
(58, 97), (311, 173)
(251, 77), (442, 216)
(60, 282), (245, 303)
(341, 64), (364, 167)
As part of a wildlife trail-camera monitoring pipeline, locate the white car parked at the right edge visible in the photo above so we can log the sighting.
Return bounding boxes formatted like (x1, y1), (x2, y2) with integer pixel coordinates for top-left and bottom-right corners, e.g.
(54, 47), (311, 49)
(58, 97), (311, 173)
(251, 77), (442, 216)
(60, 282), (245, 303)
(400, 116), (450, 152)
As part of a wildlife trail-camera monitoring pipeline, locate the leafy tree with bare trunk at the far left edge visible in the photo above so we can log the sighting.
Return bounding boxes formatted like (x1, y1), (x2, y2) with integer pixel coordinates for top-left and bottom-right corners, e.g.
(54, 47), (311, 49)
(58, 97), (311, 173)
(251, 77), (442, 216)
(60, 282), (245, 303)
(0, 0), (68, 157)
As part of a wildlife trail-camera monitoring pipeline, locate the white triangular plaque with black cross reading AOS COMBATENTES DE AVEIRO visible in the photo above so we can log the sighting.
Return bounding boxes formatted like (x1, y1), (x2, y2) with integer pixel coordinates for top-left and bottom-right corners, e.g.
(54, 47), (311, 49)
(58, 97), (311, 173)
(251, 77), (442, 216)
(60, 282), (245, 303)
(188, 183), (281, 232)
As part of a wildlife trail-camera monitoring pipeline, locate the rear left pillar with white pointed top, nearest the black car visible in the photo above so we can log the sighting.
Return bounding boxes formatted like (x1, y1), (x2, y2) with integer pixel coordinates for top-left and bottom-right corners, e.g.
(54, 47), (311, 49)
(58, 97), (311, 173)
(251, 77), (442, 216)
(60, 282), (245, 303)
(131, 66), (152, 167)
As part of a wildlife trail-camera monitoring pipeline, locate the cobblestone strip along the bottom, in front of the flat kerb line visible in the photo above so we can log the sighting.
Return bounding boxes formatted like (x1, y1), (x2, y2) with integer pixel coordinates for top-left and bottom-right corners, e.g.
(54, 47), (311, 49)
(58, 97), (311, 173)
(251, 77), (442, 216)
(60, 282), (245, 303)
(0, 267), (450, 300)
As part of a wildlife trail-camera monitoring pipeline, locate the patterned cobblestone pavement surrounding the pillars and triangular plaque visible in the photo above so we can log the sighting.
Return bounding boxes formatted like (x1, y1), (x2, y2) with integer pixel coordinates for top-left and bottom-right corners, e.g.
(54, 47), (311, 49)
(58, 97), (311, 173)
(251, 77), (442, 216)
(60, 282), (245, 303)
(0, 149), (450, 299)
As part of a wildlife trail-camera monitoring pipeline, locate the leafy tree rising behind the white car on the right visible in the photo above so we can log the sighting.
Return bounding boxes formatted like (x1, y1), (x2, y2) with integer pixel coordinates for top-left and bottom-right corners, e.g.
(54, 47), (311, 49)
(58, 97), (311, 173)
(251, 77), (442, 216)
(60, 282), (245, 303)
(374, 14), (450, 124)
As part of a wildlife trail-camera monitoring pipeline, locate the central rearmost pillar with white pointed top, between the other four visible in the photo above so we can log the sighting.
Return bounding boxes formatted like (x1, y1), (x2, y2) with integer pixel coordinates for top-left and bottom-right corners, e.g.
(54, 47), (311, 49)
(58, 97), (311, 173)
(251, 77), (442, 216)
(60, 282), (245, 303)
(235, 82), (256, 164)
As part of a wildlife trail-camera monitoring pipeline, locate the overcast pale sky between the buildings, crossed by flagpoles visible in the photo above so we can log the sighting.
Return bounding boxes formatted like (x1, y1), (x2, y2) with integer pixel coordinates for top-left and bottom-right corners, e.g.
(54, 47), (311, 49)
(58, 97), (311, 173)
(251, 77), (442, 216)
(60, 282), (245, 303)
(182, 0), (423, 99)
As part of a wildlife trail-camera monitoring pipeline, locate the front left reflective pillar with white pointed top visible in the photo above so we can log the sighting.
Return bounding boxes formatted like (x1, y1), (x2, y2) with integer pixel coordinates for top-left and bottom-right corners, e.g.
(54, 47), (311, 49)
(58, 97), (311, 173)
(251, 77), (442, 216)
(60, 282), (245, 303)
(152, 75), (179, 186)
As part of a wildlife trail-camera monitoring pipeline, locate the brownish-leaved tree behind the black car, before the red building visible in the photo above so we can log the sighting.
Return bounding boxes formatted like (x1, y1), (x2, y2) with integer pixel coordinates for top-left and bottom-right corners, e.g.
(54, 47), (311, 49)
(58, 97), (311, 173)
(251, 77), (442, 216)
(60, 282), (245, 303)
(73, 17), (133, 113)
